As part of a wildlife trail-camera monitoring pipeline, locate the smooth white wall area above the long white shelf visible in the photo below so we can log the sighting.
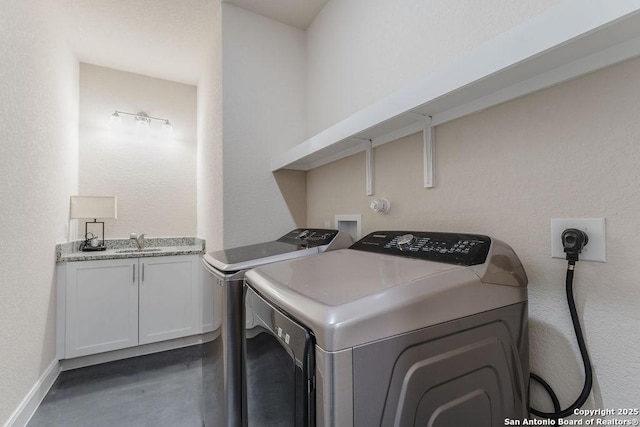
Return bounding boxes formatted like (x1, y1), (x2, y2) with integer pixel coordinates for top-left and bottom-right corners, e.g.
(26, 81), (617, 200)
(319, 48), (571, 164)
(306, 0), (559, 137)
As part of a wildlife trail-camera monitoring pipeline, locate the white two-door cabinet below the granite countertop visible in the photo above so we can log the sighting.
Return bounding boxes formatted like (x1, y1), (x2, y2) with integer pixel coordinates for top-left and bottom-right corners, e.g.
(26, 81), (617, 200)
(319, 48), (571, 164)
(58, 255), (202, 359)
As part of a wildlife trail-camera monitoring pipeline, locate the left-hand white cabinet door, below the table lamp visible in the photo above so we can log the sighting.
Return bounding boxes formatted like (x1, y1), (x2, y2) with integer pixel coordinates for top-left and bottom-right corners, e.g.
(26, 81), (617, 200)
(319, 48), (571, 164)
(65, 259), (138, 358)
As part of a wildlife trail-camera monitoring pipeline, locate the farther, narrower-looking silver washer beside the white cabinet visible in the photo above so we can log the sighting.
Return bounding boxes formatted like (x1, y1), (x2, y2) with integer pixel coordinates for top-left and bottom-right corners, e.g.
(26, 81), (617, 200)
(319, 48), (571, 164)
(202, 228), (352, 427)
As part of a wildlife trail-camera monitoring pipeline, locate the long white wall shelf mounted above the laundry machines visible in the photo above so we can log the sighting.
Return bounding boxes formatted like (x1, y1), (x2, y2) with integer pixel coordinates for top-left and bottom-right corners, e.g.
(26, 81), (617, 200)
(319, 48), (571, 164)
(271, 0), (640, 174)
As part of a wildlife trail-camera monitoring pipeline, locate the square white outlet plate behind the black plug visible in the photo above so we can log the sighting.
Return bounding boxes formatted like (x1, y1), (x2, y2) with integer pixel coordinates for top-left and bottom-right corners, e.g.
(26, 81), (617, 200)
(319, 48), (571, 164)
(551, 218), (607, 262)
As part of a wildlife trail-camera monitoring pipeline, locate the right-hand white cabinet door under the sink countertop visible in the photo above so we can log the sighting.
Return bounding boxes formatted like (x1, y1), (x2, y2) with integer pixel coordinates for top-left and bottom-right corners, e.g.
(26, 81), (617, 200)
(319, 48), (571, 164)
(139, 255), (200, 344)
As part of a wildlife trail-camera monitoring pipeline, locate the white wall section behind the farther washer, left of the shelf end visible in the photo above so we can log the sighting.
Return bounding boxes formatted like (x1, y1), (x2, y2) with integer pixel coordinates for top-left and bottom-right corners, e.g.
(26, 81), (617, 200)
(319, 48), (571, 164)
(222, 3), (306, 247)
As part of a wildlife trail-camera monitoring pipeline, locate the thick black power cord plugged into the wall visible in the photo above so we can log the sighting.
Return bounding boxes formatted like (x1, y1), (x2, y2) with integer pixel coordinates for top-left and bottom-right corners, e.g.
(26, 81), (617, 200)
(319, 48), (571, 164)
(530, 228), (593, 420)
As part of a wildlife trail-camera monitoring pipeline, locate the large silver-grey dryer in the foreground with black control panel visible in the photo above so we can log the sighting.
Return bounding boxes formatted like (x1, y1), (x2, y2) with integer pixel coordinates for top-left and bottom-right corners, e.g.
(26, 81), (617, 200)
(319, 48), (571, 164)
(245, 231), (529, 427)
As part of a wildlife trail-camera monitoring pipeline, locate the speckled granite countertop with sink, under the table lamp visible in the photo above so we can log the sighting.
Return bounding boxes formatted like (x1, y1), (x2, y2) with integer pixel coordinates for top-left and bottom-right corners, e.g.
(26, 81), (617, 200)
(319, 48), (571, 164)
(56, 237), (205, 262)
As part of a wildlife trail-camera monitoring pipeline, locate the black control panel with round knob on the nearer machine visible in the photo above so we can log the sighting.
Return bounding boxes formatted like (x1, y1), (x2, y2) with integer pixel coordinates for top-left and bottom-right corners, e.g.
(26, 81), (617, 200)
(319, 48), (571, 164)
(350, 231), (491, 266)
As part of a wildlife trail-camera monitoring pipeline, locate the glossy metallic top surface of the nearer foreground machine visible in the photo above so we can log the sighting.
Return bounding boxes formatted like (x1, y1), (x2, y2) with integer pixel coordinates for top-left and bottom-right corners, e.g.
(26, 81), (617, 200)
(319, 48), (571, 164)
(245, 249), (526, 351)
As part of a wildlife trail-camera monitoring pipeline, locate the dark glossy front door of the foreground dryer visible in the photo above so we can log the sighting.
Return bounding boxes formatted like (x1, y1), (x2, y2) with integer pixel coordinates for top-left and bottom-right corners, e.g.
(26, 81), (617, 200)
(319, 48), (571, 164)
(244, 284), (315, 427)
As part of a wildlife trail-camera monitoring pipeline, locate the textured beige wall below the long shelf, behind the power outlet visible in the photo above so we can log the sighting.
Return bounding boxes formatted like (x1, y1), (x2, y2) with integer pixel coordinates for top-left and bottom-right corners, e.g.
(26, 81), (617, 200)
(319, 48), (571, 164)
(307, 51), (640, 410)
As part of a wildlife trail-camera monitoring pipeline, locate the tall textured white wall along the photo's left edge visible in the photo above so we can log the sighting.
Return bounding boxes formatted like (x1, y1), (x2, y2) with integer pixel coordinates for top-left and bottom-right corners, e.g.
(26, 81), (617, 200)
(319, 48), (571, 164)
(0, 0), (78, 425)
